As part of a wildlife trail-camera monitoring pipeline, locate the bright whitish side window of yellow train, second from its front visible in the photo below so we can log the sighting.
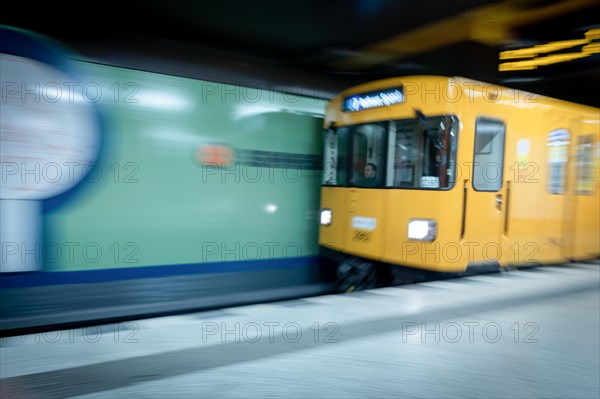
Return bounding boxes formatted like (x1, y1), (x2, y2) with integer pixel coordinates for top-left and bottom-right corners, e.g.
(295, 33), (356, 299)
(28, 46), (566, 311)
(547, 129), (571, 194)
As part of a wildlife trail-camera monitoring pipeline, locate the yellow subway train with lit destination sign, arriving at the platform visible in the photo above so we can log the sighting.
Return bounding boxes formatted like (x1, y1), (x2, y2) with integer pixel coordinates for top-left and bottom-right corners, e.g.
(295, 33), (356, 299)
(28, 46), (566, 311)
(319, 76), (600, 291)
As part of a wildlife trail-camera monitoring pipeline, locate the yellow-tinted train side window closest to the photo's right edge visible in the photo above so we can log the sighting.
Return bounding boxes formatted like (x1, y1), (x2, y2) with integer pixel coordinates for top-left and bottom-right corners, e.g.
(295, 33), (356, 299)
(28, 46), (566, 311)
(575, 134), (599, 195)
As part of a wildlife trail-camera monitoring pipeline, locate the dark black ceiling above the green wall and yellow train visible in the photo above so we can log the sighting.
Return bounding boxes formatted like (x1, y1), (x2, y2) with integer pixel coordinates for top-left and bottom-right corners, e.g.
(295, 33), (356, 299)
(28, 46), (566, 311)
(0, 0), (600, 106)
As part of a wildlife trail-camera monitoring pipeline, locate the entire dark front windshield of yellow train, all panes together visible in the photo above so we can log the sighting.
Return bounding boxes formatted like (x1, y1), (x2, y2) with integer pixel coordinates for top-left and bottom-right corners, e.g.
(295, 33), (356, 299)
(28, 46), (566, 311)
(323, 113), (458, 189)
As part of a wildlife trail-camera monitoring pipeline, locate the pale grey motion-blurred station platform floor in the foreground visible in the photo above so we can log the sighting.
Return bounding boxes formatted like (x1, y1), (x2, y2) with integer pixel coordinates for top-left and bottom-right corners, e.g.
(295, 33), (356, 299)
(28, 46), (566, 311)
(0, 261), (600, 399)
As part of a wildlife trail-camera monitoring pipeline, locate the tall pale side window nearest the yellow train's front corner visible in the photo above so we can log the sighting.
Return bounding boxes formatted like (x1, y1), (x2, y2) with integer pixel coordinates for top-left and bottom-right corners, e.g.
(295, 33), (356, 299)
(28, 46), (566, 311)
(473, 117), (506, 191)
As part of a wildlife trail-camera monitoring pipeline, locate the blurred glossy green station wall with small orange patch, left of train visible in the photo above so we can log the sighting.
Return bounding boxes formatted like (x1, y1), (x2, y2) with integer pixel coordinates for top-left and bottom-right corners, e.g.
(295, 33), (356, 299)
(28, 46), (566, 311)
(43, 61), (324, 271)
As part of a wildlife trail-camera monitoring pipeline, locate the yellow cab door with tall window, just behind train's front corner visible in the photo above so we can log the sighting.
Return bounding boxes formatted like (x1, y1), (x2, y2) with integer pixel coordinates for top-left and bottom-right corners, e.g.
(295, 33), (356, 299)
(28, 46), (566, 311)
(463, 117), (506, 266)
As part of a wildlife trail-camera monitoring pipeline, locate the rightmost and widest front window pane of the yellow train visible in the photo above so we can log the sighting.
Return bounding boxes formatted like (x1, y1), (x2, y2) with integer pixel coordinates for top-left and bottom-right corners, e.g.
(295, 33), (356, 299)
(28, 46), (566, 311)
(390, 116), (458, 189)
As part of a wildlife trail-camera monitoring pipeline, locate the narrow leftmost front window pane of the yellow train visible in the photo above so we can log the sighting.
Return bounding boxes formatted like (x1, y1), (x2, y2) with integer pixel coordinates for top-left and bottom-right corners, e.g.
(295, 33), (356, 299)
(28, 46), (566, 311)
(323, 127), (348, 186)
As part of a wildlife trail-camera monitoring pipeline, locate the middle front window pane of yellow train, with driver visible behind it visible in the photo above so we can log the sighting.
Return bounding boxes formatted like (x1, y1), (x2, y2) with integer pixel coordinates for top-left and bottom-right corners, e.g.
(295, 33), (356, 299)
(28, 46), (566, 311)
(350, 123), (387, 187)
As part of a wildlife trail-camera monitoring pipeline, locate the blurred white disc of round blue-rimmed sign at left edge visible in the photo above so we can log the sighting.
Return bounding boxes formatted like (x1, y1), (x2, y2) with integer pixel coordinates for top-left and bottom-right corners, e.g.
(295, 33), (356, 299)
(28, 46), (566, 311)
(0, 54), (99, 200)
